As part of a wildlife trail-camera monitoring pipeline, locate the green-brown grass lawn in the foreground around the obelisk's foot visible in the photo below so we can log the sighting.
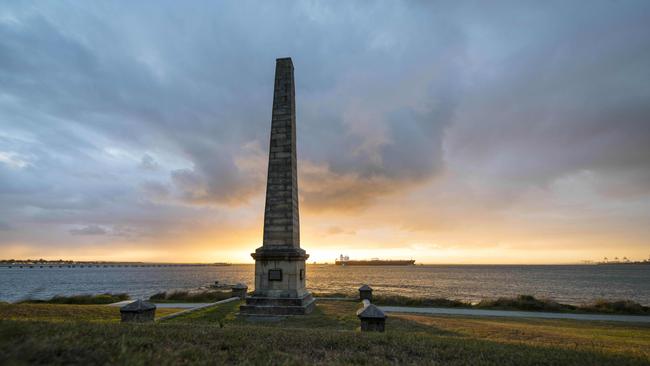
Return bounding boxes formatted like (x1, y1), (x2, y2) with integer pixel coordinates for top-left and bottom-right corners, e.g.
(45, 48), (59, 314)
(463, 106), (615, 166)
(0, 301), (650, 365)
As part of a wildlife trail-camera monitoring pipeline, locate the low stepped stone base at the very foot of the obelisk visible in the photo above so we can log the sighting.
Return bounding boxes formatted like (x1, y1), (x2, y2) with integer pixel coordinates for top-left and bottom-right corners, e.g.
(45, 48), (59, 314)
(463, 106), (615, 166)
(239, 293), (316, 315)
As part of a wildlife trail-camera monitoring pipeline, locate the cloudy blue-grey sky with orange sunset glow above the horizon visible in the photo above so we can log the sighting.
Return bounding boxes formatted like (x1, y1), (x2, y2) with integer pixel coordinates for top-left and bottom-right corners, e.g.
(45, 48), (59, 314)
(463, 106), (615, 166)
(0, 0), (650, 264)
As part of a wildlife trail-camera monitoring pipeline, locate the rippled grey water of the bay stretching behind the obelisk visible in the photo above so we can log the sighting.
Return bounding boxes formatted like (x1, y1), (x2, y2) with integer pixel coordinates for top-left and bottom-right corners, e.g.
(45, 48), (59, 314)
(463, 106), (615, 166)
(0, 265), (650, 305)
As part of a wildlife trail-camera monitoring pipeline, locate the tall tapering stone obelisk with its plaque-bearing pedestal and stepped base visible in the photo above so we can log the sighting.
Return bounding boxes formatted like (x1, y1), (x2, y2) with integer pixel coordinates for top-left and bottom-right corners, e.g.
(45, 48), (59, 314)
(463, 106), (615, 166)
(240, 58), (314, 315)
